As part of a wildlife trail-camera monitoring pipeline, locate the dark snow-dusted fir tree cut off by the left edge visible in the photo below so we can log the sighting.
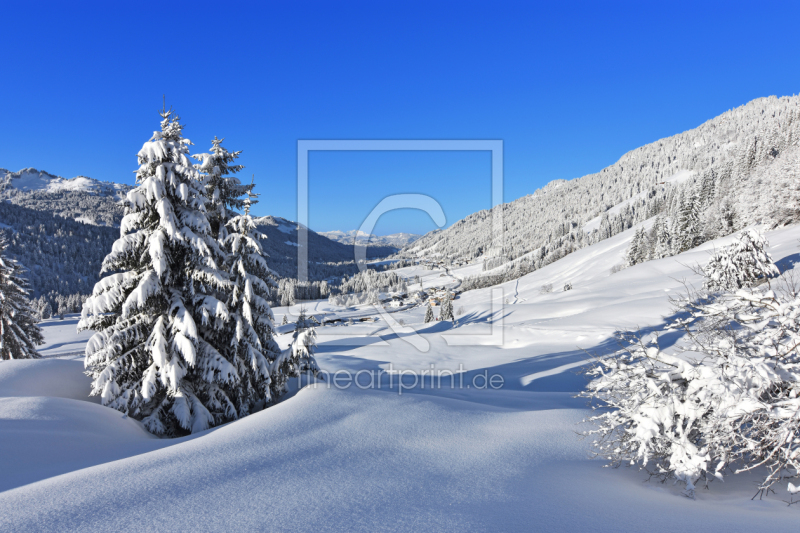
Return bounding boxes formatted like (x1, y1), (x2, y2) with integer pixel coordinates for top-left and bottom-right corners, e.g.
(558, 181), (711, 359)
(0, 238), (44, 360)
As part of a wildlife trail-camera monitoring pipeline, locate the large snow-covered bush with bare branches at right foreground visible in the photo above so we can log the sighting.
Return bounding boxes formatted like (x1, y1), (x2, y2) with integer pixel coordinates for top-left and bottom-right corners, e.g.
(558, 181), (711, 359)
(581, 278), (800, 495)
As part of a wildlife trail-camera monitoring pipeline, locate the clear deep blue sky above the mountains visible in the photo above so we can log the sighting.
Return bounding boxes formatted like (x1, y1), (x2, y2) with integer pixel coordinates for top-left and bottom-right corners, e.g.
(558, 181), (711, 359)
(0, 1), (800, 234)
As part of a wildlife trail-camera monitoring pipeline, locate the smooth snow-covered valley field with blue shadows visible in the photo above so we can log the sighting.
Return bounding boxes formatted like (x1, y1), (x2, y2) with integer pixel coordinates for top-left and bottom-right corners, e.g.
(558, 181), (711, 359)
(0, 222), (800, 532)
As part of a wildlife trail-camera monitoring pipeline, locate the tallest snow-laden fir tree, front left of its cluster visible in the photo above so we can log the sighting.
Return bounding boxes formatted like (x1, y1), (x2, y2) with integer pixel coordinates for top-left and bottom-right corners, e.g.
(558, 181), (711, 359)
(78, 110), (243, 436)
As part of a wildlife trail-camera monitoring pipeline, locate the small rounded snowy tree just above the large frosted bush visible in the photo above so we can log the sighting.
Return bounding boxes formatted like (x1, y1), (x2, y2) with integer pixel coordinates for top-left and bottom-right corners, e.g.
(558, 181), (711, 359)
(702, 225), (779, 291)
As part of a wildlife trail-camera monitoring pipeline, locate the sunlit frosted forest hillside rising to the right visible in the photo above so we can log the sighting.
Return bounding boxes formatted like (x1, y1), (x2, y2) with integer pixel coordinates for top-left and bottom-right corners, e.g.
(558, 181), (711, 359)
(401, 96), (800, 281)
